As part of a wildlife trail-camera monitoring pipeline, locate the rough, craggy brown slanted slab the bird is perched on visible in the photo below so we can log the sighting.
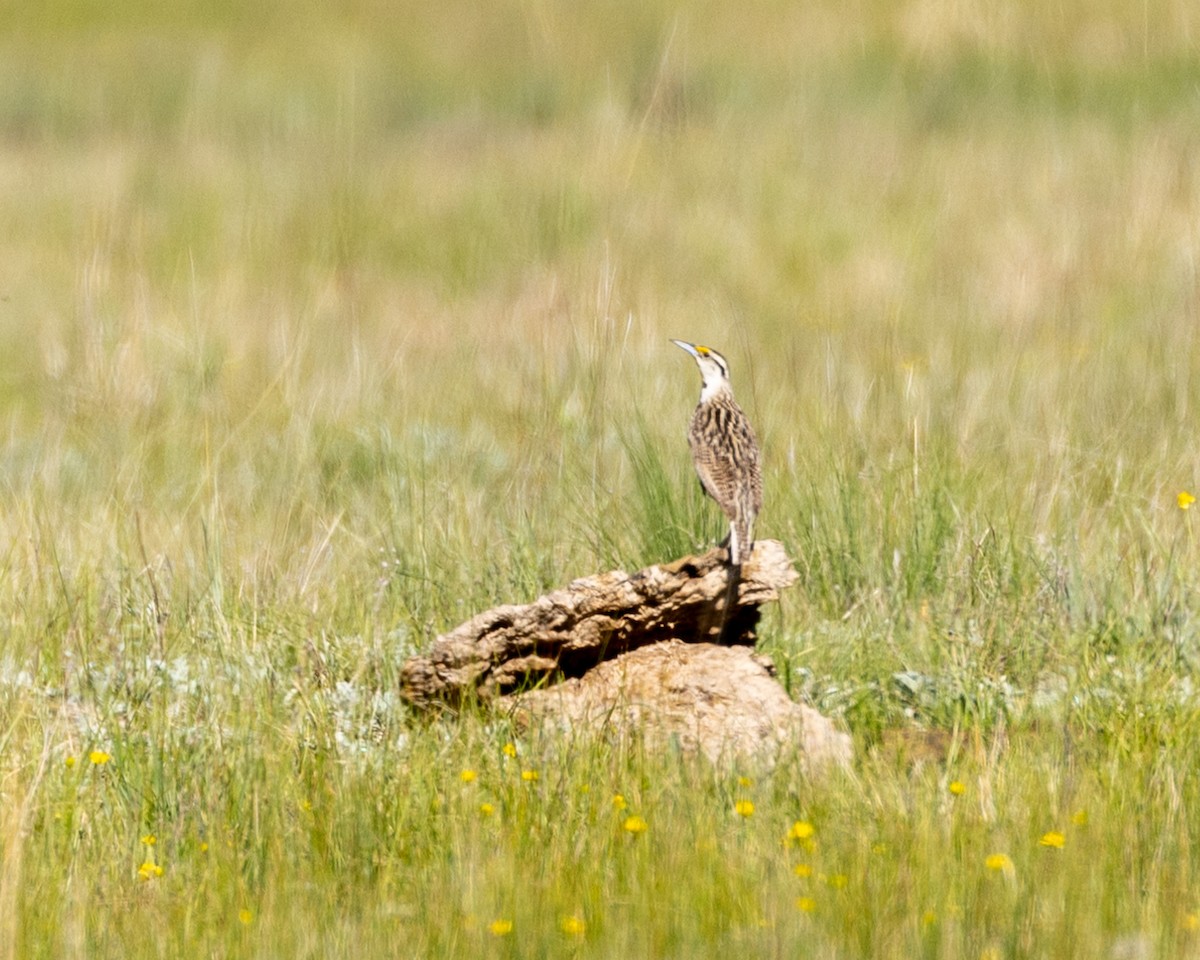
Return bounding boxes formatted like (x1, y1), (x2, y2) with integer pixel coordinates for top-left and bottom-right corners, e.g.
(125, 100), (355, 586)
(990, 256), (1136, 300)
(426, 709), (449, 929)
(401, 540), (797, 707)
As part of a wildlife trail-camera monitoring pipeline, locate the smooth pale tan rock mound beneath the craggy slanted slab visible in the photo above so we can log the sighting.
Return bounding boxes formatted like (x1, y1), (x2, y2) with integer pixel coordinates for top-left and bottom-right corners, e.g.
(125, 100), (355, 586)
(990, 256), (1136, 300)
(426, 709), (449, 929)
(502, 640), (851, 769)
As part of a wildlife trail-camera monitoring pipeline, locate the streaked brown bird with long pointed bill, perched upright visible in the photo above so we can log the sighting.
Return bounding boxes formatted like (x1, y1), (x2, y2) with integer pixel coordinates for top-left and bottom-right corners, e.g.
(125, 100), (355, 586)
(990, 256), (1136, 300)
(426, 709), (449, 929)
(671, 340), (762, 569)
